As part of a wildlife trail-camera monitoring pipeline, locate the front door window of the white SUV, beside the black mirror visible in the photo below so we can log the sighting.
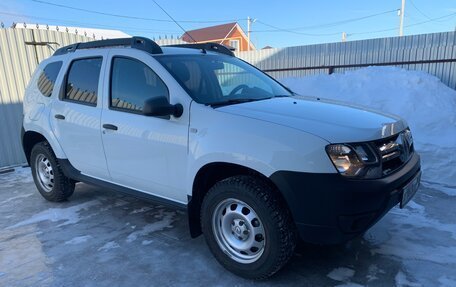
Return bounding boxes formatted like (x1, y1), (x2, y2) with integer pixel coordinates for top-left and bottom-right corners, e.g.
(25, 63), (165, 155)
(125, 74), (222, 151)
(110, 57), (168, 113)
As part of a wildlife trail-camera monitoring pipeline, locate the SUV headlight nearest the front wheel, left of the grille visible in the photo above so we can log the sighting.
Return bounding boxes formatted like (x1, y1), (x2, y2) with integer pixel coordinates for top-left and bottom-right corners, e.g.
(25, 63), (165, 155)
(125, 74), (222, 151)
(326, 144), (382, 178)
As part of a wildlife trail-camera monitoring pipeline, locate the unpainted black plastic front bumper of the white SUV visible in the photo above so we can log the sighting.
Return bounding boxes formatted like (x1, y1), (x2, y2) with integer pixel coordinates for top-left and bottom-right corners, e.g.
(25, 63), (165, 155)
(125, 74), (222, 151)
(270, 152), (420, 244)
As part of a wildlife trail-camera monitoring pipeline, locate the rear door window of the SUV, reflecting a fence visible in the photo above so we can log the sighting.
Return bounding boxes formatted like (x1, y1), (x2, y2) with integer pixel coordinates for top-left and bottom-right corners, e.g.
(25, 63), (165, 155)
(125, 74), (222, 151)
(64, 57), (103, 106)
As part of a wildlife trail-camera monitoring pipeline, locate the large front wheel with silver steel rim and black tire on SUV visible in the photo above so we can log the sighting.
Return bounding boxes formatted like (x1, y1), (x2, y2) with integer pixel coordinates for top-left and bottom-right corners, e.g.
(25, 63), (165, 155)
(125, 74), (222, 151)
(201, 176), (297, 279)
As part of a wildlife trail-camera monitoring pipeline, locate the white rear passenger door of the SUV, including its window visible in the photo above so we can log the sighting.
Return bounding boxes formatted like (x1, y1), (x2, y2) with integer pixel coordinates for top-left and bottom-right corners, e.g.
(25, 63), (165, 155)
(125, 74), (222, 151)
(50, 50), (110, 180)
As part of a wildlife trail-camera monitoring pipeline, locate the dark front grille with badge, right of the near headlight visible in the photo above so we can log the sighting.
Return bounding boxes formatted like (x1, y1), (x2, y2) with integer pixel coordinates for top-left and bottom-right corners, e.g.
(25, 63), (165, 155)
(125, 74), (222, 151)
(375, 130), (414, 176)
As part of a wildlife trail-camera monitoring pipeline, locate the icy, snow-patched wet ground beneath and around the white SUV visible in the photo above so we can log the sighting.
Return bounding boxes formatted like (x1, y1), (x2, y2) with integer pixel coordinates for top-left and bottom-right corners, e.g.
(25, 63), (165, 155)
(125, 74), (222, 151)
(0, 168), (456, 287)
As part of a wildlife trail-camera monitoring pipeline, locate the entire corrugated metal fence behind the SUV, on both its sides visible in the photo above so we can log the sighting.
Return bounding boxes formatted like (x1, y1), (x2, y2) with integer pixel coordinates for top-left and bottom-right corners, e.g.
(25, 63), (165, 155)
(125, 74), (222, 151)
(0, 28), (456, 167)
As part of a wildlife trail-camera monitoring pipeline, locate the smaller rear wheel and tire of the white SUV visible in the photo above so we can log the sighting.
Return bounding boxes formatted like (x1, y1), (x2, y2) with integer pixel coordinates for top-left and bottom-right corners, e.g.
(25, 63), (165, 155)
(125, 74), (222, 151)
(30, 142), (75, 202)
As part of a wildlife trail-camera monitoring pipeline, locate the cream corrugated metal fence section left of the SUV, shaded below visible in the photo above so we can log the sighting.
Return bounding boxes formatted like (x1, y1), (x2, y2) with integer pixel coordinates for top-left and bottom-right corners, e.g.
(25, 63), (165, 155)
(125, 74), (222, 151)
(0, 28), (91, 167)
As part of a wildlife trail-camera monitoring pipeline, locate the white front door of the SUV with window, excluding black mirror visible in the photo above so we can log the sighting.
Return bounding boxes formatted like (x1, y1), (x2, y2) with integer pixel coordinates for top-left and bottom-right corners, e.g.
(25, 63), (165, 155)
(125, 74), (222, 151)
(102, 49), (190, 204)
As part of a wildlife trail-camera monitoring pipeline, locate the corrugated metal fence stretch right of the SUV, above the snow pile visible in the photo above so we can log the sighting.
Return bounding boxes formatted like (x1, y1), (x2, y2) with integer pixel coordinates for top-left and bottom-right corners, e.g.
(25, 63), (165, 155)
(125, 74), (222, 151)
(236, 32), (456, 89)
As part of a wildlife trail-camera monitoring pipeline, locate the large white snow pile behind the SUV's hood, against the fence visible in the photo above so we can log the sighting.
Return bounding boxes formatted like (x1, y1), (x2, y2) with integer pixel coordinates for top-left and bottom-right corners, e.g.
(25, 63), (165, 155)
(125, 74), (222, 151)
(280, 67), (456, 191)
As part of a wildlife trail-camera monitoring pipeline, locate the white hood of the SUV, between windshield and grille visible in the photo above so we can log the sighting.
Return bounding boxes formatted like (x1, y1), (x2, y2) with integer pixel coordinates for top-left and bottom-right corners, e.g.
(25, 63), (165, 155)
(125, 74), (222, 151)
(216, 97), (407, 143)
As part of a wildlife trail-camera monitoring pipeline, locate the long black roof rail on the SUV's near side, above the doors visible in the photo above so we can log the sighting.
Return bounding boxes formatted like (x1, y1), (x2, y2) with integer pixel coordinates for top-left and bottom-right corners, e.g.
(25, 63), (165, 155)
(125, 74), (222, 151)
(54, 37), (163, 56)
